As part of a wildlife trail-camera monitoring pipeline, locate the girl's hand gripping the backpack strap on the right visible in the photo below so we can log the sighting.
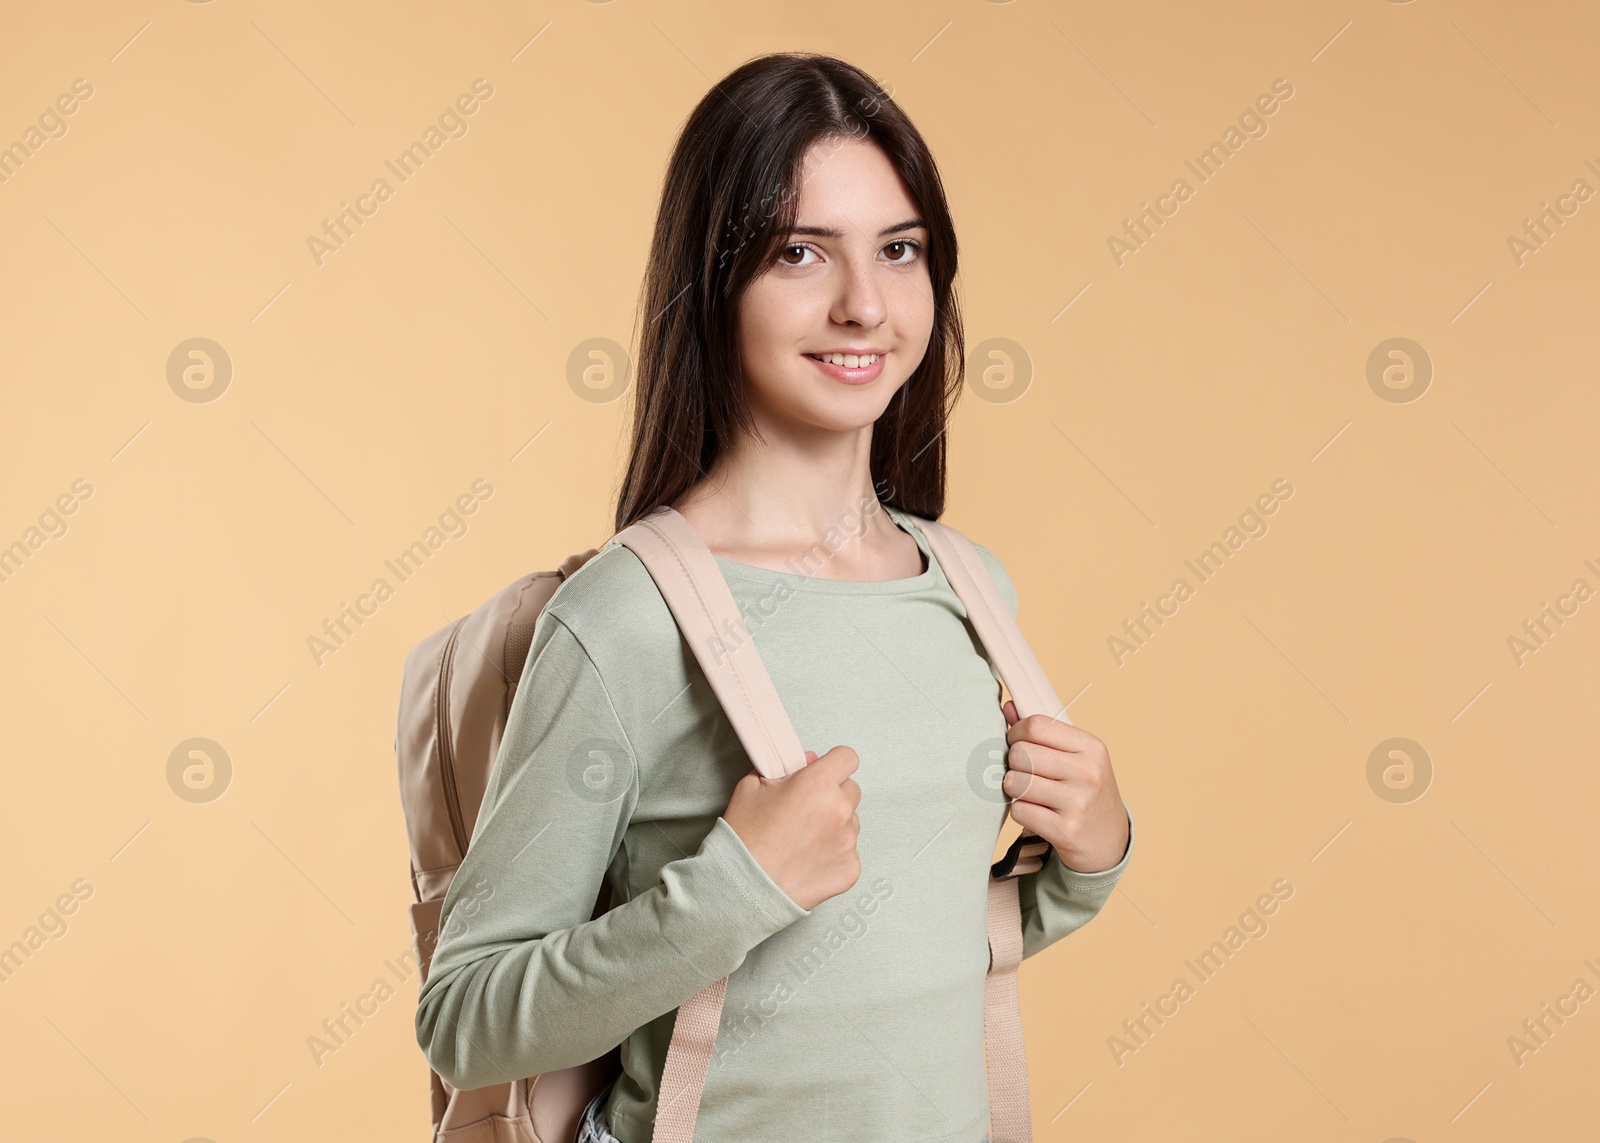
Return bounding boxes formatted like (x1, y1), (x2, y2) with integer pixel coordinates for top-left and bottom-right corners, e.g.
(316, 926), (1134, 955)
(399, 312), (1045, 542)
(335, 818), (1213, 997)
(1002, 700), (1130, 872)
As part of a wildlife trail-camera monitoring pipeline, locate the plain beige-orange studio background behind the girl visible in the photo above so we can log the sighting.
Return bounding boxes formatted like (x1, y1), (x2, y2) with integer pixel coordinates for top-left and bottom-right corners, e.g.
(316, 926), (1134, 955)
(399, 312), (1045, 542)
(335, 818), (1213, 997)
(0, 0), (1600, 1143)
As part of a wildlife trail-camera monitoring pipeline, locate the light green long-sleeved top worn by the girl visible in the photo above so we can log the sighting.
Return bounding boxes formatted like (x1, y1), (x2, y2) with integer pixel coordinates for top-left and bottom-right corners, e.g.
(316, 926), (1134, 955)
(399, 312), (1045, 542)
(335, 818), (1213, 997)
(416, 506), (1133, 1143)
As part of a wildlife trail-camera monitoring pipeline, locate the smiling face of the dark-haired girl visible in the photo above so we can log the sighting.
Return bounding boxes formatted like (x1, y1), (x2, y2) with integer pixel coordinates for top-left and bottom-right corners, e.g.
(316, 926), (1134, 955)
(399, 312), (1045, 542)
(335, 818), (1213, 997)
(739, 138), (933, 434)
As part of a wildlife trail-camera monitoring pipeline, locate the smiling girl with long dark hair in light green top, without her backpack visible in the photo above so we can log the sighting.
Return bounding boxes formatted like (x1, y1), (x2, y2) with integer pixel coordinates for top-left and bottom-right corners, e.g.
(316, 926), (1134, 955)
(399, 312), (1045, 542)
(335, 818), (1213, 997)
(416, 53), (1133, 1143)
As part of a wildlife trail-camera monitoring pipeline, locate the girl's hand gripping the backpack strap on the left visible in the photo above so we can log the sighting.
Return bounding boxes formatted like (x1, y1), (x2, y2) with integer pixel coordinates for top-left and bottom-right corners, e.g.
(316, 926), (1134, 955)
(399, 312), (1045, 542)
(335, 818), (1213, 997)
(722, 746), (861, 909)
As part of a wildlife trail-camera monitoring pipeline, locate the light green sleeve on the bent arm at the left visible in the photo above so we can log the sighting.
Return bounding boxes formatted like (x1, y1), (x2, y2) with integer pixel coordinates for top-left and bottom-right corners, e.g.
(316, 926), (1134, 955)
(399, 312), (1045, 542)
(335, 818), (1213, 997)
(416, 608), (808, 1089)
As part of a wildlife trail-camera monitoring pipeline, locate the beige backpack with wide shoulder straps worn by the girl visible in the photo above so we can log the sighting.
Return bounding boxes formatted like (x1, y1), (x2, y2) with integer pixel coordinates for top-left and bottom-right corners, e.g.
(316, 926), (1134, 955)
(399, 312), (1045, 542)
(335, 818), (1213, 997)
(395, 506), (1069, 1143)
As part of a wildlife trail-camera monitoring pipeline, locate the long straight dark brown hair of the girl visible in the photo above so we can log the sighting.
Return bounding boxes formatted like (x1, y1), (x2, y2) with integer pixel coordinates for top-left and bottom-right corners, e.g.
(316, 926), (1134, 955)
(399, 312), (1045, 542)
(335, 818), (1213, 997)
(616, 51), (965, 531)
